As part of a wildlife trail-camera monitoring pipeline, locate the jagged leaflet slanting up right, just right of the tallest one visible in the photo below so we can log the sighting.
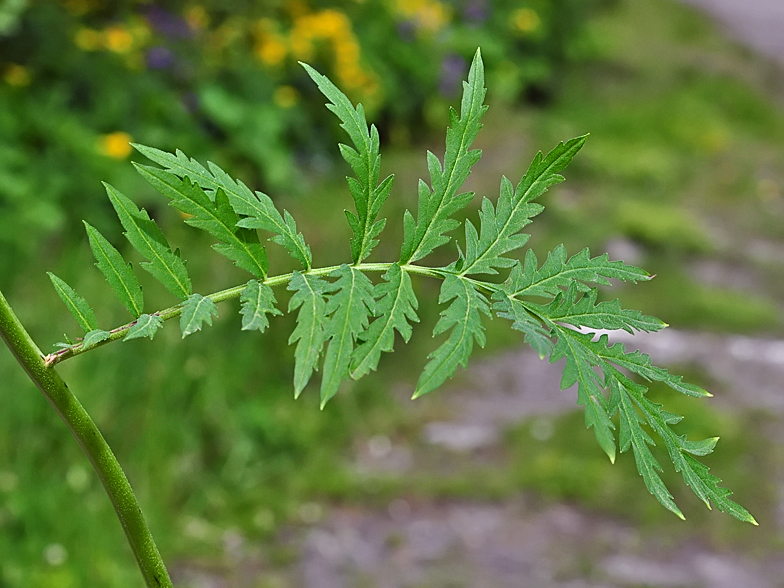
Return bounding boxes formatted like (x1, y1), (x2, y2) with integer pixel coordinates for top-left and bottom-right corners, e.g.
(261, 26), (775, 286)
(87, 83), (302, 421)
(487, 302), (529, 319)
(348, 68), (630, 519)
(460, 135), (587, 275)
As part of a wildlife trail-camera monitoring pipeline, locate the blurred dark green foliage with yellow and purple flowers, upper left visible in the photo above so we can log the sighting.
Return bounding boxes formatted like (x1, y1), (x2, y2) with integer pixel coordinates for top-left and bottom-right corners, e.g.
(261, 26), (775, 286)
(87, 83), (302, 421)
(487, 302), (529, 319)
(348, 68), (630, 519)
(0, 0), (607, 272)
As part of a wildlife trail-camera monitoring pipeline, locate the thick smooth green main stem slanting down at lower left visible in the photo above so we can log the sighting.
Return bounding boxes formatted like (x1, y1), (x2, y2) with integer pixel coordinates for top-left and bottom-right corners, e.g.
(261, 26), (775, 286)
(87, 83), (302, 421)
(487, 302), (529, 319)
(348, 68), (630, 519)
(0, 292), (172, 588)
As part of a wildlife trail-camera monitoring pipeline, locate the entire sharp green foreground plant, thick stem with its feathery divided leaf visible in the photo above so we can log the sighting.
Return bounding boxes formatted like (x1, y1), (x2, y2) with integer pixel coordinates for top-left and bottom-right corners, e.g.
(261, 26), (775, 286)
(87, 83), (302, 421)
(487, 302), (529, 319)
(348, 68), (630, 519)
(2, 51), (757, 586)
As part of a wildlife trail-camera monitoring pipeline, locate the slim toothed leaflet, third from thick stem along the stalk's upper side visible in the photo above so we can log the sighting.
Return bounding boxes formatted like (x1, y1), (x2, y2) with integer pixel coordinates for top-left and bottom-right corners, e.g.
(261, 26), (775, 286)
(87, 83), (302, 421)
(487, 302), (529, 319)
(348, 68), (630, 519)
(104, 182), (191, 300)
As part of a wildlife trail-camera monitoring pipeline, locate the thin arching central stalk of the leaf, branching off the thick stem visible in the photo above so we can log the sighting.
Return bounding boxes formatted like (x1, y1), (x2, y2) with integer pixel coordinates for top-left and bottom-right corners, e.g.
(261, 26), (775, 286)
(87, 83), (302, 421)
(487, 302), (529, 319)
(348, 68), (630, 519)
(44, 263), (454, 367)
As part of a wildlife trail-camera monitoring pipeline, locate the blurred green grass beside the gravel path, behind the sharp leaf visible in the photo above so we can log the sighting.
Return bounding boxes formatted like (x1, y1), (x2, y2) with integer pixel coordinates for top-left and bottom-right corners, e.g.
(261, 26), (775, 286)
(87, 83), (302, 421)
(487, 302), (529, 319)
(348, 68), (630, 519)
(0, 0), (784, 588)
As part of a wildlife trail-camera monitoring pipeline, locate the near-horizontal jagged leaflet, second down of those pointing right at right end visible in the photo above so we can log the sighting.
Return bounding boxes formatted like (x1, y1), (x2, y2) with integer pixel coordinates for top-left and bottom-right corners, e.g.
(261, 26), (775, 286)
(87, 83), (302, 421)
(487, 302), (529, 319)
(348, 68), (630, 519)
(528, 282), (667, 333)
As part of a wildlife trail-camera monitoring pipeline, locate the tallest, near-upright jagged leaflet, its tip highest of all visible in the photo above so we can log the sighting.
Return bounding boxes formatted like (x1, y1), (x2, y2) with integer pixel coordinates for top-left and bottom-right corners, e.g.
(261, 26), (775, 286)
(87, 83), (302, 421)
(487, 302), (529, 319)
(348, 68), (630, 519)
(400, 50), (487, 263)
